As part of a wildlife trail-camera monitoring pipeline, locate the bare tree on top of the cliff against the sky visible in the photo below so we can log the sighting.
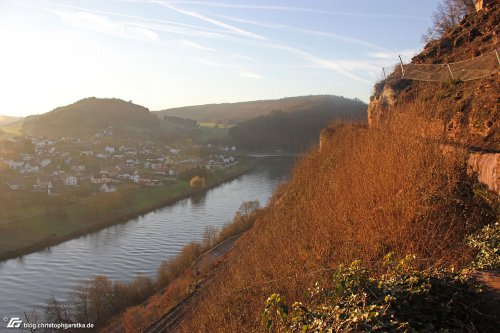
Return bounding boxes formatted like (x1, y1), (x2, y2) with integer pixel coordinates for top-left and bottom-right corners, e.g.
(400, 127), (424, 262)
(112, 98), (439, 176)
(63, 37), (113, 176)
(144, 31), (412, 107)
(422, 0), (475, 43)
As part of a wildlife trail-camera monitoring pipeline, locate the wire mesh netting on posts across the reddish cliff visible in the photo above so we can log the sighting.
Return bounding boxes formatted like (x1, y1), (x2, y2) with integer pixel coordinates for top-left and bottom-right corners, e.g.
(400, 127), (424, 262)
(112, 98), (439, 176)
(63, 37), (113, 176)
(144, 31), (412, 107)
(383, 51), (500, 82)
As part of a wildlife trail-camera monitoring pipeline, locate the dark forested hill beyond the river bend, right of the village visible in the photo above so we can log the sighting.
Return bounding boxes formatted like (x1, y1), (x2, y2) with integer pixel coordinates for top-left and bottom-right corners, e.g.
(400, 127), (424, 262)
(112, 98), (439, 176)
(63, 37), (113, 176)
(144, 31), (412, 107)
(229, 96), (367, 151)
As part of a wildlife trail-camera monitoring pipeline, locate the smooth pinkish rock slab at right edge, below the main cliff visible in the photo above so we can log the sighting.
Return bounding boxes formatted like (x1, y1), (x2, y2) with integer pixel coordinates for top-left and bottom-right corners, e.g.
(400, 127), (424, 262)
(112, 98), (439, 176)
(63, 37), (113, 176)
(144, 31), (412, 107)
(467, 153), (500, 195)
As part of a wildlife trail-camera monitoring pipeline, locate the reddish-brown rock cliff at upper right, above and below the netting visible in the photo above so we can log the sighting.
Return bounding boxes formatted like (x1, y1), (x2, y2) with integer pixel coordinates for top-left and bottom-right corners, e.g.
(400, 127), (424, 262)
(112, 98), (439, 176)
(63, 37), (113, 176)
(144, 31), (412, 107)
(368, 1), (500, 194)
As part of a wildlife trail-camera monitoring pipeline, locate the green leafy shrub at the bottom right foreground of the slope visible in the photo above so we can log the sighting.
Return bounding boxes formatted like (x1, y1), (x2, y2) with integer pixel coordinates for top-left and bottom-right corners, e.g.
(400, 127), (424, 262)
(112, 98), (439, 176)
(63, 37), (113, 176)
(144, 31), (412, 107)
(262, 253), (486, 332)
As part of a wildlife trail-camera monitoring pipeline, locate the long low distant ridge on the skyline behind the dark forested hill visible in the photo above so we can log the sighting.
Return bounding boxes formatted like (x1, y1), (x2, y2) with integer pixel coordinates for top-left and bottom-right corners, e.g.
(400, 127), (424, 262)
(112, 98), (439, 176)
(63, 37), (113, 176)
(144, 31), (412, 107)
(153, 95), (362, 125)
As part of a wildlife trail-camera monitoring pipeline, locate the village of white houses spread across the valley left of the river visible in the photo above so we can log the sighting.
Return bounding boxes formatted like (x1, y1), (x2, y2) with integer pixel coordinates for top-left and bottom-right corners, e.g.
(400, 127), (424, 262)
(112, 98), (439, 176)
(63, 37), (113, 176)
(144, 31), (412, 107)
(0, 130), (238, 197)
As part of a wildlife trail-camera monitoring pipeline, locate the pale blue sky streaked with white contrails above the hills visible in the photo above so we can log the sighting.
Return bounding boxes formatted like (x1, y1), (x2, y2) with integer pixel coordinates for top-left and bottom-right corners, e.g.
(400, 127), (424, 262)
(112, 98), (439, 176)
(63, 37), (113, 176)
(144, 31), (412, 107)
(0, 0), (437, 116)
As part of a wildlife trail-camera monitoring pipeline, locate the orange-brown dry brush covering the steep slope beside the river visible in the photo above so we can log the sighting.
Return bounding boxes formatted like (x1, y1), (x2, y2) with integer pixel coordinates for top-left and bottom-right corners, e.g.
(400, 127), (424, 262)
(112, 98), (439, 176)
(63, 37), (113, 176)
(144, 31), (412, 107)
(178, 105), (493, 332)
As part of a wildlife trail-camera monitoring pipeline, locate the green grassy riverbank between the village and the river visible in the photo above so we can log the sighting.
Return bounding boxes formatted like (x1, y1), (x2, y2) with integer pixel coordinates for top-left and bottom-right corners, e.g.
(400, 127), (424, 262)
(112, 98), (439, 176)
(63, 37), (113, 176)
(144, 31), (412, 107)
(0, 159), (261, 261)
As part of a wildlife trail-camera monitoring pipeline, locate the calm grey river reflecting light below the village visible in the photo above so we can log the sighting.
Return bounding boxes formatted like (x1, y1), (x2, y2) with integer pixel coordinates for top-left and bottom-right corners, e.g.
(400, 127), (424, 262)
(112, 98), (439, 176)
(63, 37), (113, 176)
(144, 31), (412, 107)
(0, 157), (295, 331)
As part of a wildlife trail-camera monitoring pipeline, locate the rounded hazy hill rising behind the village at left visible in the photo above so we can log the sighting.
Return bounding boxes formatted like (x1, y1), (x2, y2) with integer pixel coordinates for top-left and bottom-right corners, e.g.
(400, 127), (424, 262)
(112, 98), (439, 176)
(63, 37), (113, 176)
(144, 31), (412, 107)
(21, 97), (159, 137)
